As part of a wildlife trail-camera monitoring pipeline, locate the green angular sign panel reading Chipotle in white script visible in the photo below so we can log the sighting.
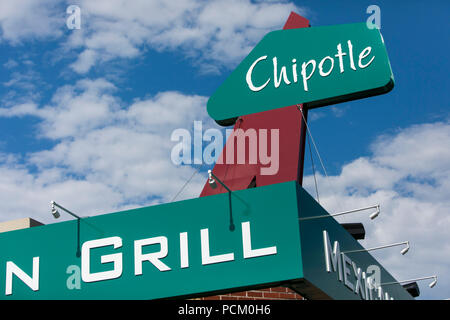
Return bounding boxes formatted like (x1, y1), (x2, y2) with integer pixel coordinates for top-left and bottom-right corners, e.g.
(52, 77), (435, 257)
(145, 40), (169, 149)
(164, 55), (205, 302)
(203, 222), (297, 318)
(207, 23), (394, 123)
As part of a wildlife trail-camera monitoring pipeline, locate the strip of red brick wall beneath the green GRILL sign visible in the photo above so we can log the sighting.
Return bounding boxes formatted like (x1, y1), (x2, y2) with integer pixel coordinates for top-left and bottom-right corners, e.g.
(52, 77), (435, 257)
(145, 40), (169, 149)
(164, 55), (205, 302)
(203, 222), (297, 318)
(197, 287), (304, 300)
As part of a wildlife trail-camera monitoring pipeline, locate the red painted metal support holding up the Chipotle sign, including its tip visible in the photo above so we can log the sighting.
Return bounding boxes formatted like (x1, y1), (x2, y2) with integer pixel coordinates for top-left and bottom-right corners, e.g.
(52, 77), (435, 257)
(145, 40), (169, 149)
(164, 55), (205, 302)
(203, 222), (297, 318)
(200, 12), (309, 197)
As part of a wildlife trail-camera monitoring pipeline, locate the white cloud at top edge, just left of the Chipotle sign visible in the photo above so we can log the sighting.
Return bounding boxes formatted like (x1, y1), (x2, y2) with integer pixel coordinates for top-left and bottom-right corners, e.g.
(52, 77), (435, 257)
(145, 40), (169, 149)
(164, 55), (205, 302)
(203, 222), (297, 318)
(66, 0), (304, 73)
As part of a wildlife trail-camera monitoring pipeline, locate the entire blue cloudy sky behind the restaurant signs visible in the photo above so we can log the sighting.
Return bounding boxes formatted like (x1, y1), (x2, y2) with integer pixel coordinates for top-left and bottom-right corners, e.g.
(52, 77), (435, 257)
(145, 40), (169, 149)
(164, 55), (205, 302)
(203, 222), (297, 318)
(0, 0), (450, 299)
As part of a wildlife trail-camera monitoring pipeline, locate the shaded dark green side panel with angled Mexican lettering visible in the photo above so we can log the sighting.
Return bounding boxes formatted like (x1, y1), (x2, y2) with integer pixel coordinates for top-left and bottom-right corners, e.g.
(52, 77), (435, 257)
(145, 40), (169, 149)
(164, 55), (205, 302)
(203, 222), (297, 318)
(293, 188), (413, 300)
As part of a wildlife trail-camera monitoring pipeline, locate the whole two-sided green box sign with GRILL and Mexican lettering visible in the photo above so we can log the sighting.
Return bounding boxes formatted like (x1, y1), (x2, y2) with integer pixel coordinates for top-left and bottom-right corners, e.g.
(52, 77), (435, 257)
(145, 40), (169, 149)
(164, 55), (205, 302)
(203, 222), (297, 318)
(0, 181), (411, 299)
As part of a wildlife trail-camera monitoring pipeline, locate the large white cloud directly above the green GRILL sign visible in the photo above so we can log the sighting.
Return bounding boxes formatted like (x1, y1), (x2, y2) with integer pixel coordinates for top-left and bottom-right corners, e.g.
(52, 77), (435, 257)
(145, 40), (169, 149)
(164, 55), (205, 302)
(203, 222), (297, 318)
(0, 79), (213, 226)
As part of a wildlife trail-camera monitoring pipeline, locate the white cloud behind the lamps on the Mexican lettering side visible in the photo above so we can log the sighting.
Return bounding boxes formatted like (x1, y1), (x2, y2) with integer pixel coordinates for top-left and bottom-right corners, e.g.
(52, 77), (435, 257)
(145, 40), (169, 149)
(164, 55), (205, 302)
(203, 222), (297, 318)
(304, 122), (450, 299)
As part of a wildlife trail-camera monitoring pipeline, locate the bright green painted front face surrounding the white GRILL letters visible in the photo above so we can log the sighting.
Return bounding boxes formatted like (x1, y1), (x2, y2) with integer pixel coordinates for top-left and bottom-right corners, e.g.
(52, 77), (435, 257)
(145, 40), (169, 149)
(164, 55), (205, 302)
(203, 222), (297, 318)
(0, 183), (303, 299)
